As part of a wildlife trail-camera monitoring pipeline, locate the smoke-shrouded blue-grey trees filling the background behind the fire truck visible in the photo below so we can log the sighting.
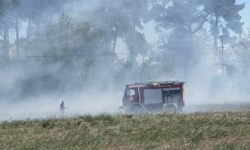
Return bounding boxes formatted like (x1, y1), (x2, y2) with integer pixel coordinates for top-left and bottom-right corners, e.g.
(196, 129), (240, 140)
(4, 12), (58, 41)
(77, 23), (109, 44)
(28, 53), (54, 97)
(0, 0), (250, 113)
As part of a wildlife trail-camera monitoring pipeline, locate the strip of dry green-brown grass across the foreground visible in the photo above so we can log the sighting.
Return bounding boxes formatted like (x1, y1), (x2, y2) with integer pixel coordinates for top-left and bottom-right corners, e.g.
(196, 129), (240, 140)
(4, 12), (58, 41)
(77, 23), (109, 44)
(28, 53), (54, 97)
(0, 112), (250, 150)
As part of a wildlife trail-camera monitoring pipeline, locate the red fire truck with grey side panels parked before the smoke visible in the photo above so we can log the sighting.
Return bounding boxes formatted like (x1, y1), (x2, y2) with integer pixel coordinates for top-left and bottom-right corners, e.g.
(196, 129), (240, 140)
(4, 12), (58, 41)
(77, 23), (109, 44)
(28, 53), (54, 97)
(123, 81), (185, 113)
